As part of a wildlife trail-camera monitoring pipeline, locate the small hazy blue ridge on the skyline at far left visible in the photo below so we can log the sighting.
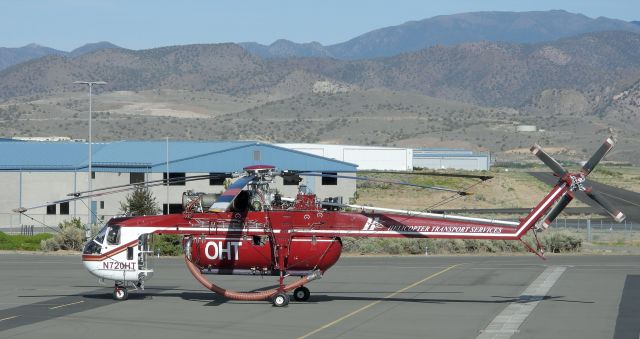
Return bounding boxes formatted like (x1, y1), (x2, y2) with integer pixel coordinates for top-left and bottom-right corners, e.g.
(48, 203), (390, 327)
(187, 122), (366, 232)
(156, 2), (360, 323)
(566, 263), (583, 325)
(0, 41), (120, 70)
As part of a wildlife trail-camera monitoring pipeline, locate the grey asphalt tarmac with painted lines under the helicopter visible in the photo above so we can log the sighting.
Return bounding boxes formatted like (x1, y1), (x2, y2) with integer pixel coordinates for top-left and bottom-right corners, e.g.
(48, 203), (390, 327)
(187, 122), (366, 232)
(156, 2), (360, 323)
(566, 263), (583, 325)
(0, 254), (640, 339)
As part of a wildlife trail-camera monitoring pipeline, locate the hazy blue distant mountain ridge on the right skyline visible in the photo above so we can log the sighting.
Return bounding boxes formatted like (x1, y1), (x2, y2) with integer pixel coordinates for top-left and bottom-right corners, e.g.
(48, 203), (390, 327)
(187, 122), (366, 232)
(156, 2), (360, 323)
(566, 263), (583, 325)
(240, 10), (640, 59)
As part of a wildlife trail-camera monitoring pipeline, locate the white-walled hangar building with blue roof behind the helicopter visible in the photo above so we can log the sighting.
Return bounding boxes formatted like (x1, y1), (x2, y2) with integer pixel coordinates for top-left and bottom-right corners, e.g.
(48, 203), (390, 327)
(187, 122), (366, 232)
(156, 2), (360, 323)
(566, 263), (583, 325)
(0, 141), (357, 227)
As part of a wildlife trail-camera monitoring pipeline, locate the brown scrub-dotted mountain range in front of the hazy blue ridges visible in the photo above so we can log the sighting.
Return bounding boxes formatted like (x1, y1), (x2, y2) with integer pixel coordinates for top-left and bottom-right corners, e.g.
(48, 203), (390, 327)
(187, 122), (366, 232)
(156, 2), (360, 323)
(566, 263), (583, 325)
(0, 31), (640, 112)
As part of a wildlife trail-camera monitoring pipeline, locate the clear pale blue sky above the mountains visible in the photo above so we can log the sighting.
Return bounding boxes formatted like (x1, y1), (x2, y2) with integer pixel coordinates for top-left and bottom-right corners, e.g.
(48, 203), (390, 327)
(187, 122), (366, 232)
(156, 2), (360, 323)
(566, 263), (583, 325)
(0, 0), (640, 51)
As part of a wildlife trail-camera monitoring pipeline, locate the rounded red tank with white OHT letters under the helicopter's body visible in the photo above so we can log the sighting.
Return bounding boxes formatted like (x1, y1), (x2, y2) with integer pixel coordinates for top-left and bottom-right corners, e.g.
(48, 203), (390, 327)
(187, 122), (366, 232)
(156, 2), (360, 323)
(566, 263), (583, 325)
(184, 236), (342, 276)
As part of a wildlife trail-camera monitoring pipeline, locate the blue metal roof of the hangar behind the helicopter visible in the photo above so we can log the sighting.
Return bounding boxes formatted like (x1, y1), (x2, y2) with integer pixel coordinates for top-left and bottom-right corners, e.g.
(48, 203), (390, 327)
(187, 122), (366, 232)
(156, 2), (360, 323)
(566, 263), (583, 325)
(0, 141), (357, 173)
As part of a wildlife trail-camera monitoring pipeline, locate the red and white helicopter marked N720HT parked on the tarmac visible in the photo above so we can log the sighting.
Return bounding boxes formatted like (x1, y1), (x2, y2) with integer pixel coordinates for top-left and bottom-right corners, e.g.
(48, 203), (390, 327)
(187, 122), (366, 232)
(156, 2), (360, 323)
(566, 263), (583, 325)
(16, 138), (625, 307)
